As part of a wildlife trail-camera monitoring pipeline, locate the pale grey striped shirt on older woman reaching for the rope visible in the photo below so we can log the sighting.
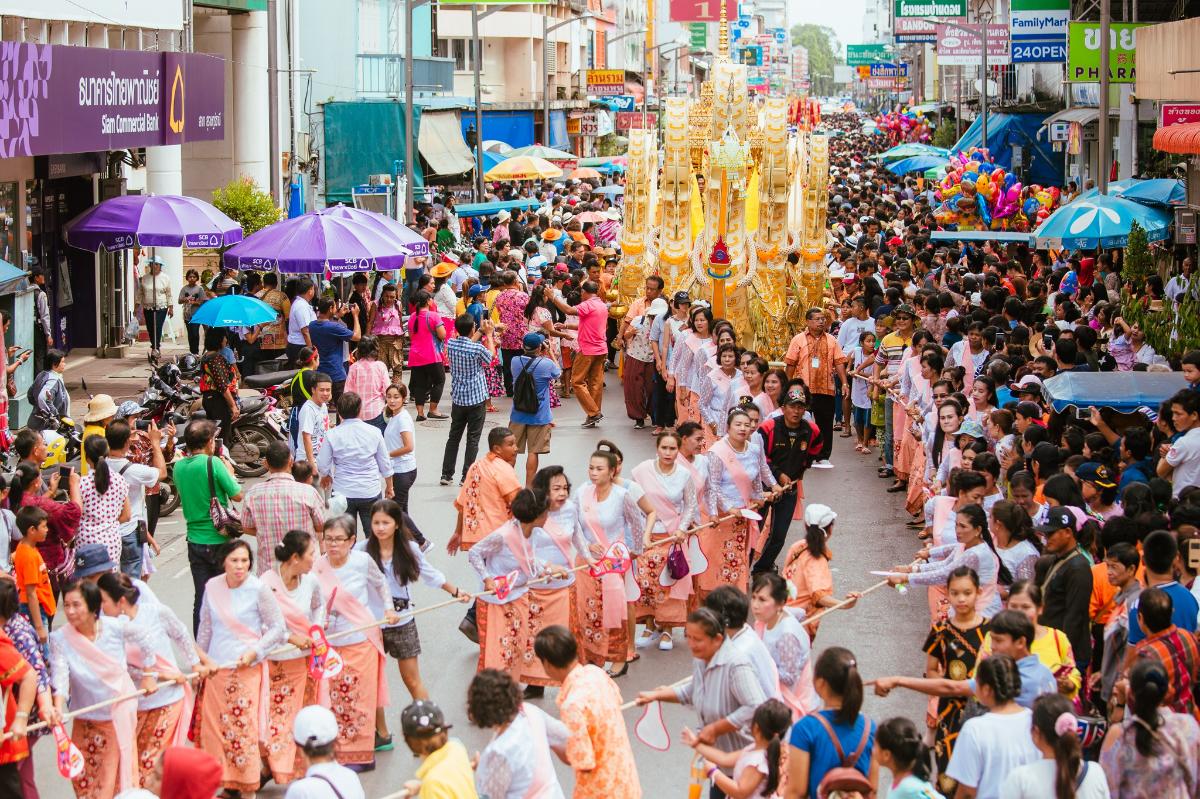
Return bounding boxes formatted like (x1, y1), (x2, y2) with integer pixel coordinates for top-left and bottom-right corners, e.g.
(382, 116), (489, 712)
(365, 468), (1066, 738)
(674, 638), (767, 752)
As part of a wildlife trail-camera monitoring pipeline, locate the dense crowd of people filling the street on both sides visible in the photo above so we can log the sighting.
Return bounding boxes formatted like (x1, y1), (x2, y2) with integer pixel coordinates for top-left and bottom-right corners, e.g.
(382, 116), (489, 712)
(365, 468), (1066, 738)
(0, 107), (1200, 799)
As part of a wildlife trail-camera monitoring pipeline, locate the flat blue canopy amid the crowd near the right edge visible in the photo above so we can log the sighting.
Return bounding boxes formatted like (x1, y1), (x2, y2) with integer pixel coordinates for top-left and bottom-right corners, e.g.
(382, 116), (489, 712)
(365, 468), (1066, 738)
(1042, 372), (1188, 414)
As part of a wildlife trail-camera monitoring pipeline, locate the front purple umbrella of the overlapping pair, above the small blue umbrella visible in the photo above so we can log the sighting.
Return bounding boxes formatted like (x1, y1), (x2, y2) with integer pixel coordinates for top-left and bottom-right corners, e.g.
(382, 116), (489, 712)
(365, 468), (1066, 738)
(224, 214), (408, 275)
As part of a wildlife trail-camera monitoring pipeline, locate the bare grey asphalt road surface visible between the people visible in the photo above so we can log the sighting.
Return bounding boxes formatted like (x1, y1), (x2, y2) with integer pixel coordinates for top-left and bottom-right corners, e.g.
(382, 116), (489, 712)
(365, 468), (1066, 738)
(35, 372), (929, 799)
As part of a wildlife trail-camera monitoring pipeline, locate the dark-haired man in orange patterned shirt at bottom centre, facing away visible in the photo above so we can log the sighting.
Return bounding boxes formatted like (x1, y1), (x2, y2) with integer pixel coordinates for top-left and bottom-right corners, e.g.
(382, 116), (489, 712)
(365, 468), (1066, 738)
(533, 624), (642, 799)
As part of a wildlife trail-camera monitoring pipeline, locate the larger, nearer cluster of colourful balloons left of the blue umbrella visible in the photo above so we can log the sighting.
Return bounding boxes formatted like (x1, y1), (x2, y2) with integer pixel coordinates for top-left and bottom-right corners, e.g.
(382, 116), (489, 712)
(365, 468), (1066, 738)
(934, 148), (1061, 232)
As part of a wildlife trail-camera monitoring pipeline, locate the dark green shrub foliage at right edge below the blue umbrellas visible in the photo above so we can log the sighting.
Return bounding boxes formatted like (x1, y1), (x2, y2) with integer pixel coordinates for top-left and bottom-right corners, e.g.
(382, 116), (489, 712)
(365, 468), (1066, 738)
(1121, 222), (1200, 360)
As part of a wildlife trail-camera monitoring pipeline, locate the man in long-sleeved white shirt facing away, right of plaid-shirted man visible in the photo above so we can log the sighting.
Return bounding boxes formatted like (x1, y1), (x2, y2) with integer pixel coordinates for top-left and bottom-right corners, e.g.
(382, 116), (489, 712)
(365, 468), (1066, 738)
(317, 391), (392, 530)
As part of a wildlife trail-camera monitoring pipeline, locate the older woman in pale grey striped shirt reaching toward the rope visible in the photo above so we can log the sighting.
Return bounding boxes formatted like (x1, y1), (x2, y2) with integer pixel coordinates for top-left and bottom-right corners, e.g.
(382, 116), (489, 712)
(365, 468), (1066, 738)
(636, 607), (767, 767)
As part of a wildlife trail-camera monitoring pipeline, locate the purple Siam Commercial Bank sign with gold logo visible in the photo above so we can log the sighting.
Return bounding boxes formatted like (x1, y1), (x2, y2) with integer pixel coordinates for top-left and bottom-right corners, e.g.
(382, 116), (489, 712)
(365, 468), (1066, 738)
(0, 42), (224, 157)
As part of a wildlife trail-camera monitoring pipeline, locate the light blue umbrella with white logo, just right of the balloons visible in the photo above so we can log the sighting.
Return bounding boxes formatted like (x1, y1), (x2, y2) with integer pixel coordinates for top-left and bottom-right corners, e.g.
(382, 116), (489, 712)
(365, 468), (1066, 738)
(1033, 194), (1171, 250)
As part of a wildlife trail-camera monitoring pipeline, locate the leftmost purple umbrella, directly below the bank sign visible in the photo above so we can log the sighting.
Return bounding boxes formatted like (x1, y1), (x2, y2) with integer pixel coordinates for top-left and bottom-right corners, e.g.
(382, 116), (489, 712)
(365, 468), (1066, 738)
(66, 194), (241, 252)
